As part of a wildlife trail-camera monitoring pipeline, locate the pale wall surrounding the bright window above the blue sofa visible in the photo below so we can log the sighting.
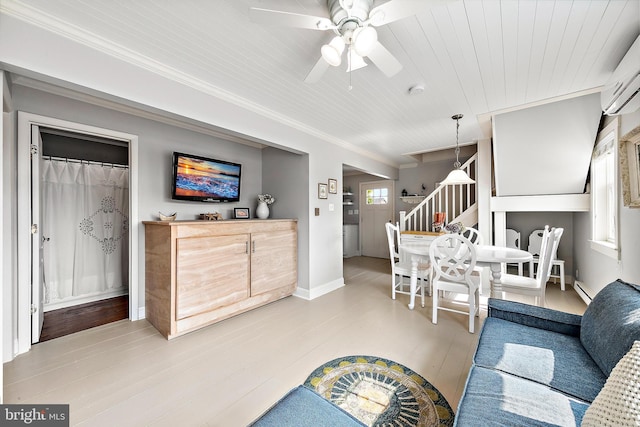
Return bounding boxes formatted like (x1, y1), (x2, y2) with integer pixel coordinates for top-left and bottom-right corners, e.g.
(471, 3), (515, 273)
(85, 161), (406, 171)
(573, 111), (640, 298)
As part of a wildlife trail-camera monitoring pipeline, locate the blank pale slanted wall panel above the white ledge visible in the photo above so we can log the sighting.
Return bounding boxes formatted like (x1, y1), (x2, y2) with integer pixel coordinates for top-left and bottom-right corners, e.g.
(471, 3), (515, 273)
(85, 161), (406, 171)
(493, 93), (602, 196)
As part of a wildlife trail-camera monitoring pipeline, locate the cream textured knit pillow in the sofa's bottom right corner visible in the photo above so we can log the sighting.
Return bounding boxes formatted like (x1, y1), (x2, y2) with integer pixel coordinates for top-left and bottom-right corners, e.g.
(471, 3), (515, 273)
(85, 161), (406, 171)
(582, 341), (640, 427)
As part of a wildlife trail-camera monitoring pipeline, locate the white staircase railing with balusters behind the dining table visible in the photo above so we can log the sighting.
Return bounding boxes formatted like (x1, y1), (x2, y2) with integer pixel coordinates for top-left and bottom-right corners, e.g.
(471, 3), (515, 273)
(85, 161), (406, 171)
(400, 153), (478, 231)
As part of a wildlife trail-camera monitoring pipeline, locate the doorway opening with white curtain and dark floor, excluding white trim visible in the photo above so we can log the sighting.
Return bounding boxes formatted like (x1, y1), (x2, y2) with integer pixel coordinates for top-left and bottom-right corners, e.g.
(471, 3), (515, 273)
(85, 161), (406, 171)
(37, 127), (130, 342)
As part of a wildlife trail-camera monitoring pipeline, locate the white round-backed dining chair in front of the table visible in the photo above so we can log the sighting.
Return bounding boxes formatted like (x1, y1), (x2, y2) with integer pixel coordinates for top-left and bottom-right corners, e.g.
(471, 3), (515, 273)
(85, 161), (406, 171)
(429, 233), (481, 333)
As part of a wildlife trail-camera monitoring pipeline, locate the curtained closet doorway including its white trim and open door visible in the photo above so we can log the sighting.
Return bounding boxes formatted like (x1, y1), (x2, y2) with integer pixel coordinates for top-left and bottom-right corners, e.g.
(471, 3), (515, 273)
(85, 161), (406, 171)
(18, 113), (139, 353)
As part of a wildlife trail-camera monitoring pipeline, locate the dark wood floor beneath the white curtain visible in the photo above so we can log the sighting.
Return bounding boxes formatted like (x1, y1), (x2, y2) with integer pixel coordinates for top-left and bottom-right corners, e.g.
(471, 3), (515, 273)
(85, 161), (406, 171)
(40, 295), (129, 342)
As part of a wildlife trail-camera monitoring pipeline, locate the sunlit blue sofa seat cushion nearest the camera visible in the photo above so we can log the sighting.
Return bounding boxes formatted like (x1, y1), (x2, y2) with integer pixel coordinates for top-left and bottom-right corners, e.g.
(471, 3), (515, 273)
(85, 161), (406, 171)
(454, 366), (589, 427)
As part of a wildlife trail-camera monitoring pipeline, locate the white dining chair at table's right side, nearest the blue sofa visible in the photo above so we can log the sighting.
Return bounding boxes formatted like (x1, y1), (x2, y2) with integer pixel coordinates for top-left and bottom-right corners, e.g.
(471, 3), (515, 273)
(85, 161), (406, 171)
(494, 226), (564, 307)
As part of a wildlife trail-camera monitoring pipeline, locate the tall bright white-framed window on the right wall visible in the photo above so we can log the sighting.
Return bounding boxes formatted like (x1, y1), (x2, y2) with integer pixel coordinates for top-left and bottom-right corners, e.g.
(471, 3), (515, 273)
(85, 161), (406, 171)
(591, 118), (618, 258)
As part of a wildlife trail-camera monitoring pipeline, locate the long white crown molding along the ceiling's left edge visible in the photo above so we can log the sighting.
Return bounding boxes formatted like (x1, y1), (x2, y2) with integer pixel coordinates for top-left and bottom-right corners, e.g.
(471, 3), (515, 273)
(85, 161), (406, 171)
(0, 0), (398, 167)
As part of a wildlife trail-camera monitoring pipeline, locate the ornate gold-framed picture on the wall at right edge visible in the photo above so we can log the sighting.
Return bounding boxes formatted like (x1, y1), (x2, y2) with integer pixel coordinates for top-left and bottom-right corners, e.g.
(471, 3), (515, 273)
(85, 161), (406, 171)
(618, 126), (640, 208)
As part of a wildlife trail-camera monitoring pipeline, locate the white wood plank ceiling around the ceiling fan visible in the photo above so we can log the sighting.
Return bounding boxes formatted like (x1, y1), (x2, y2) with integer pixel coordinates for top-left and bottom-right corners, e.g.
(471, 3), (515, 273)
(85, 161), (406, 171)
(0, 0), (640, 164)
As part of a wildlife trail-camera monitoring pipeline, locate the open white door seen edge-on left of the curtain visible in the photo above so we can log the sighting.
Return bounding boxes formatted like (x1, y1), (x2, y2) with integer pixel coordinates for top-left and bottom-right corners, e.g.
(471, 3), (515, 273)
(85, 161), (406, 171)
(31, 125), (45, 344)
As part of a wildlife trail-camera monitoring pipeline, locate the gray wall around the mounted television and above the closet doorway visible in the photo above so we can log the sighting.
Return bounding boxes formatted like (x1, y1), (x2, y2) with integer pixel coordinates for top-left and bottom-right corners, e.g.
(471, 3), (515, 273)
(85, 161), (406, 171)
(13, 86), (262, 222)
